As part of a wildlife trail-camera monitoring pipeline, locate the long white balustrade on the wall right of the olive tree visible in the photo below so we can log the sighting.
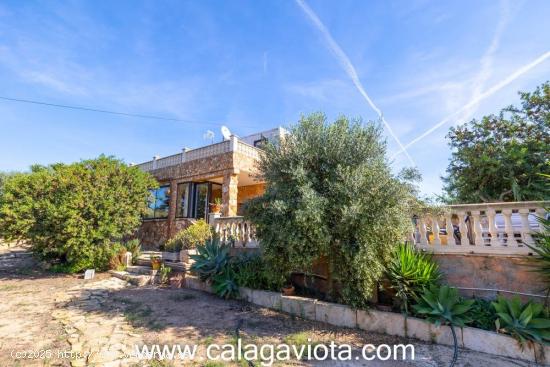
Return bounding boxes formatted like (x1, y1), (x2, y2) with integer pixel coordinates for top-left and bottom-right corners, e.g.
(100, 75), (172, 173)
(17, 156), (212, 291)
(414, 201), (550, 255)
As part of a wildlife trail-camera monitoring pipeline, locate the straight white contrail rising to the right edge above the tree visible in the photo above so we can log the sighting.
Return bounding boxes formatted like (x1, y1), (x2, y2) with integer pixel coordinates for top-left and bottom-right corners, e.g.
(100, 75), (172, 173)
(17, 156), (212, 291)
(392, 51), (550, 159)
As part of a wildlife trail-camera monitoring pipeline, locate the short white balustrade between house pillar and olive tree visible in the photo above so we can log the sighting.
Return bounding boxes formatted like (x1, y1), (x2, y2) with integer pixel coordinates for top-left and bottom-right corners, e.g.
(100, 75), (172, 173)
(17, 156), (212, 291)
(210, 216), (258, 248)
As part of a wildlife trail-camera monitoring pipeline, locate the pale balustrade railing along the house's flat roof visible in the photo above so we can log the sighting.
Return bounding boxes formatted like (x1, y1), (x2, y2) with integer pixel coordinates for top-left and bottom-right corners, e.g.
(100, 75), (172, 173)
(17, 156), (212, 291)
(137, 136), (261, 171)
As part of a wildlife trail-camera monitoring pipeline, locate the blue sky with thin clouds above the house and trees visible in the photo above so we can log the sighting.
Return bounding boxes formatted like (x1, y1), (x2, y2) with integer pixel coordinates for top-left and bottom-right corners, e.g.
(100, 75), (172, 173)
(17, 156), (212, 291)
(0, 0), (550, 194)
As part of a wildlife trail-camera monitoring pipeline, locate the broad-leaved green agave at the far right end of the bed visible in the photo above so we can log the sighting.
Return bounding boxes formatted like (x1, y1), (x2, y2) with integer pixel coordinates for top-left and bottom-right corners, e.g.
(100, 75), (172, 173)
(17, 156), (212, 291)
(493, 296), (550, 348)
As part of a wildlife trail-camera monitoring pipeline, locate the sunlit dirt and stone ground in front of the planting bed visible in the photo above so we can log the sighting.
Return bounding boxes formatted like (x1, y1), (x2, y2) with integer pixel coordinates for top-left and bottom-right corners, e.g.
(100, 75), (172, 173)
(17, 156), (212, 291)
(0, 246), (540, 367)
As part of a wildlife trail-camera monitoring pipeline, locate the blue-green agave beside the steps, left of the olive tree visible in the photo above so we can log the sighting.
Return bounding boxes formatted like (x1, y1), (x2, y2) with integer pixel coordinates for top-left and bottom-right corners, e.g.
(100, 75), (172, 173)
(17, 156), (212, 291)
(190, 240), (230, 281)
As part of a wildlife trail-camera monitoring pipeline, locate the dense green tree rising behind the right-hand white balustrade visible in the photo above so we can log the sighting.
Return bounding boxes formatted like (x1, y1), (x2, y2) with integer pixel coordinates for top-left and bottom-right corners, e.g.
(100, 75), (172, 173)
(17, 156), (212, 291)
(443, 82), (550, 203)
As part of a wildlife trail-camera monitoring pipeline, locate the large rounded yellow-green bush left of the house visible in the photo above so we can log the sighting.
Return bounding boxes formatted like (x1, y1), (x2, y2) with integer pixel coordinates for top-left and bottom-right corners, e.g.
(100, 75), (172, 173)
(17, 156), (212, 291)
(0, 156), (157, 271)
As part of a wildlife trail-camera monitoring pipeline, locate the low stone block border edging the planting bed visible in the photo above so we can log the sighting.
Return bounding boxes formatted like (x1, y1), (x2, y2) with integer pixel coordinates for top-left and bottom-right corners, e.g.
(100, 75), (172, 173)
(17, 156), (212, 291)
(185, 275), (550, 365)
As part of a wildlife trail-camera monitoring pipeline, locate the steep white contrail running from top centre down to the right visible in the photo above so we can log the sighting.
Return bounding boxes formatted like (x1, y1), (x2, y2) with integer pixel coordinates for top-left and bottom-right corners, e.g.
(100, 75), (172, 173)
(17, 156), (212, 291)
(296, 0), (416, 166)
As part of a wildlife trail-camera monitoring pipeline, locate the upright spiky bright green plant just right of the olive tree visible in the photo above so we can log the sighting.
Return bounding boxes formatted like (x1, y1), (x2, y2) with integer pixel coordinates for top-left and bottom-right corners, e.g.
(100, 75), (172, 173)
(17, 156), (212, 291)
(386, 244), (441, 314)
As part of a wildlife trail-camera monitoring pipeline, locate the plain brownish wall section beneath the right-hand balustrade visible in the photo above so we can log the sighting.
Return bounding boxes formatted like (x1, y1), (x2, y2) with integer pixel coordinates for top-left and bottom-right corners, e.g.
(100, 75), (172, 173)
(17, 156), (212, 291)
(434, 254), (545, 302)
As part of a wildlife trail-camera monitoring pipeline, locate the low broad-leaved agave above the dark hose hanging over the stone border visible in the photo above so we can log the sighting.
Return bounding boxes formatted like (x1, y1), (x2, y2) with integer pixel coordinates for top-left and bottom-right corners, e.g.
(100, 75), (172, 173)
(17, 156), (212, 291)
(413, 285), (474, 367)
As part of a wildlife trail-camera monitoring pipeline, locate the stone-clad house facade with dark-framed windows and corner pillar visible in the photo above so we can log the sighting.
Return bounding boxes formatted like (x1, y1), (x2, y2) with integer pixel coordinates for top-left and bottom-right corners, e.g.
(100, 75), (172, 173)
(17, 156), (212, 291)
(138, 128), (285, 247)
